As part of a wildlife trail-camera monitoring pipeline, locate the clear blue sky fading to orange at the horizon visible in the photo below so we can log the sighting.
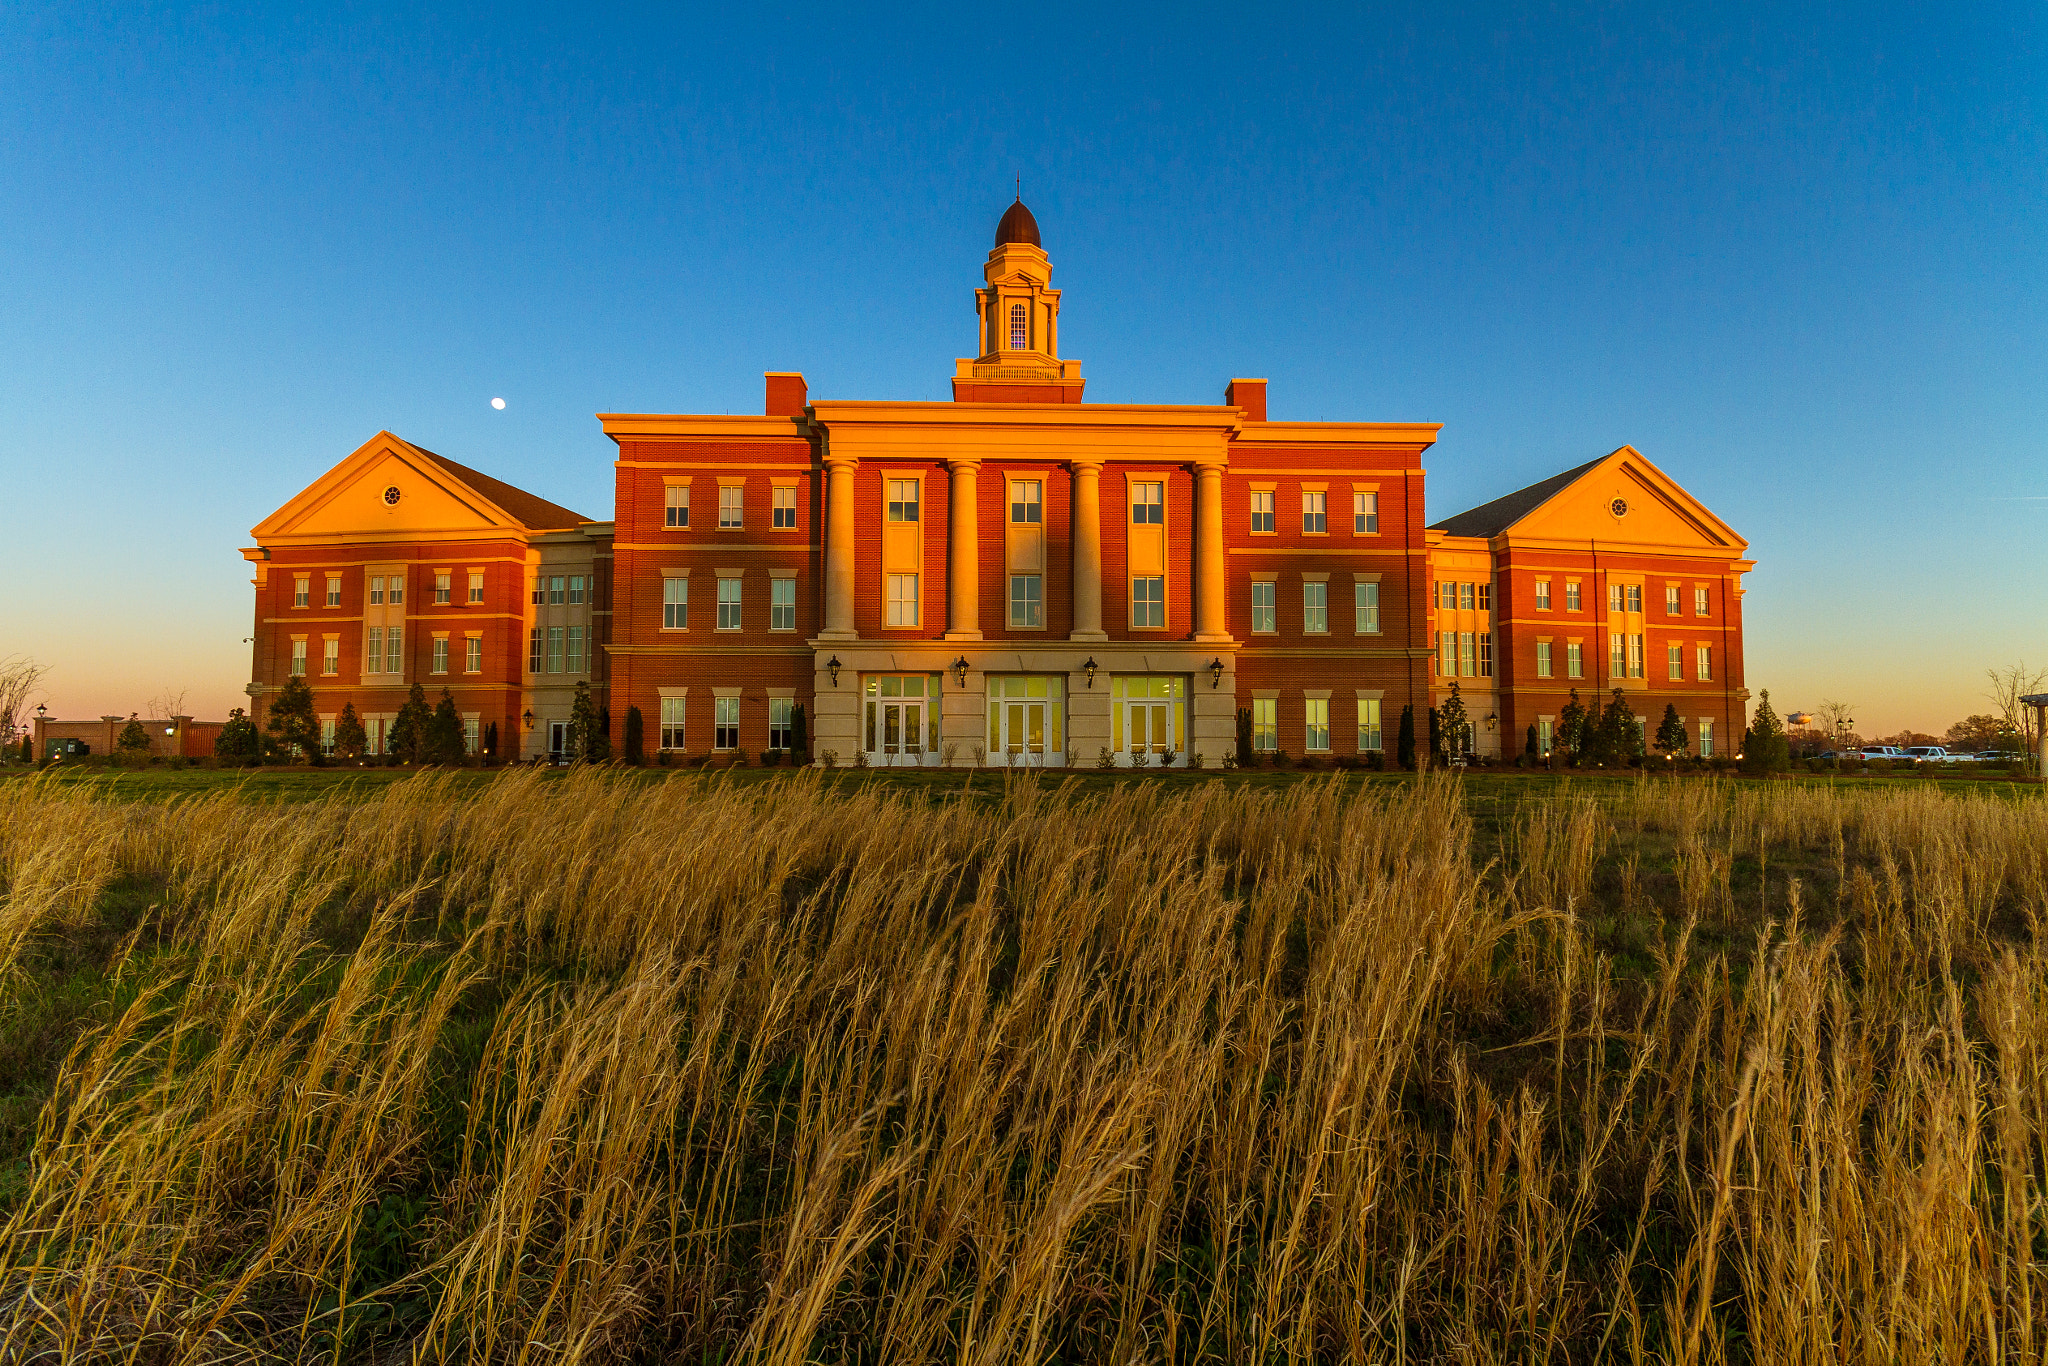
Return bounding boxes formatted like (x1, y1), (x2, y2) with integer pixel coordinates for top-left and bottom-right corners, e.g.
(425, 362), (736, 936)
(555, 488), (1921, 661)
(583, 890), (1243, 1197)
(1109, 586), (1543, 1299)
(0, 4), (2048, 733)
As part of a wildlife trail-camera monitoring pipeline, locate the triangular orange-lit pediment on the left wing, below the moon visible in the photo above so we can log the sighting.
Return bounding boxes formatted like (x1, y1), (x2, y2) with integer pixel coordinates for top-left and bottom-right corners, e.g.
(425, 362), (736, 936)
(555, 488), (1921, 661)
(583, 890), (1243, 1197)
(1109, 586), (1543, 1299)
(252, 432), (524, 541)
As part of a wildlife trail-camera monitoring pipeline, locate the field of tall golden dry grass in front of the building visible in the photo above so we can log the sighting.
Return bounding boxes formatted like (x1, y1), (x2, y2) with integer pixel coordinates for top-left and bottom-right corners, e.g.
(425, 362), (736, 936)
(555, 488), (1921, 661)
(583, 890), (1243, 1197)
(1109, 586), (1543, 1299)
(0, 770), (2048, 1366)
